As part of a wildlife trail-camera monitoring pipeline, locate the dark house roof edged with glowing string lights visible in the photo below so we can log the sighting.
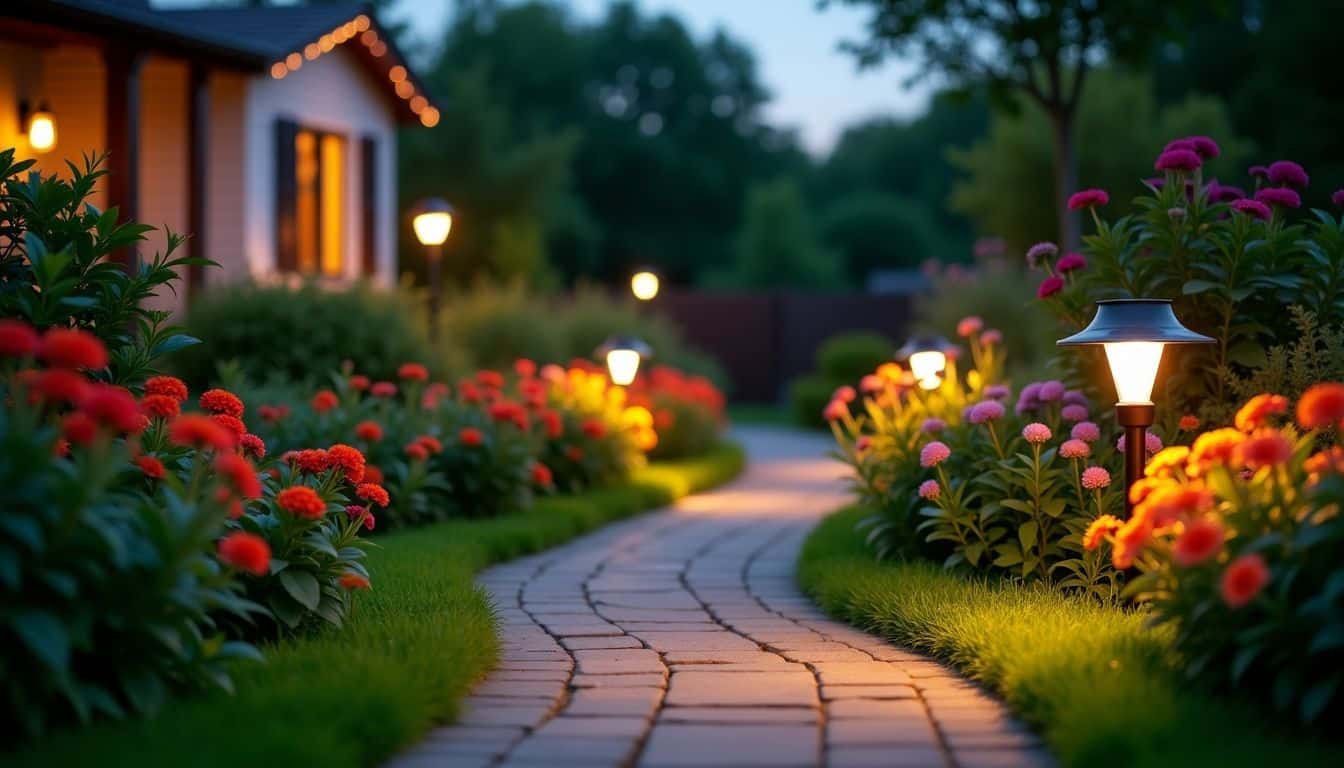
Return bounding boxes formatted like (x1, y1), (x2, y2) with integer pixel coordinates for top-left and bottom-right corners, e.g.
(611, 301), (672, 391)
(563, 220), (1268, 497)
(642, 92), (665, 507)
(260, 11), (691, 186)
(0, 0), (438, 125)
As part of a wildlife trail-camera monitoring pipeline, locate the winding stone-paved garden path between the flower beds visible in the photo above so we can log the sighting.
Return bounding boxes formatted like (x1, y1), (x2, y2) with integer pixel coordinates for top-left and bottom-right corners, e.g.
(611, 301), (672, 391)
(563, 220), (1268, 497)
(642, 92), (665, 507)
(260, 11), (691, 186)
(392, 428), (1050, 768)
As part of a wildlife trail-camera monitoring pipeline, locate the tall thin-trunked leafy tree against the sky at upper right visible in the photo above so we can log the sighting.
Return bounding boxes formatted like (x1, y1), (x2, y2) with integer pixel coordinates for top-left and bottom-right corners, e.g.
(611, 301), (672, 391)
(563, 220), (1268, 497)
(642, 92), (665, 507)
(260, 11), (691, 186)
(821, 0), (1222, 246)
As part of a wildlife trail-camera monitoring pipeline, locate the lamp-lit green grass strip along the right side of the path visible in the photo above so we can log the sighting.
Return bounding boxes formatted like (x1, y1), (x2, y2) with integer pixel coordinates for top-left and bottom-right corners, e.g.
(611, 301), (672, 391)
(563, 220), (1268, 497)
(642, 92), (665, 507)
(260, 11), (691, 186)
(798, 508), (1344, 768)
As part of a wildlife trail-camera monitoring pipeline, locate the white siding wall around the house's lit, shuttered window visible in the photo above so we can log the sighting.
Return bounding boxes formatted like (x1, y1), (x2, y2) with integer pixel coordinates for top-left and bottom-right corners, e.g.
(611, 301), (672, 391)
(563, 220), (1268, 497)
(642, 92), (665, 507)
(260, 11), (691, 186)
(243, 47), (396, 291)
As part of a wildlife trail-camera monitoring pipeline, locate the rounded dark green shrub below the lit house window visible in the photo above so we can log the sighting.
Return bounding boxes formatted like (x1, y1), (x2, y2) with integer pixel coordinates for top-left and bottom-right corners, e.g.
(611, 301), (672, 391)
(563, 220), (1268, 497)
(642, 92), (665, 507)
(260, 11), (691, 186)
(173, 284), (433, 385)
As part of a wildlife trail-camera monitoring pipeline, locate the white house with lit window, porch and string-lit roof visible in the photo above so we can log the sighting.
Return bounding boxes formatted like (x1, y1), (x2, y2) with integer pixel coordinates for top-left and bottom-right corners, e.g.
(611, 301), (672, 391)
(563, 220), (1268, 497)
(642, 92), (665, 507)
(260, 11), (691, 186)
(0, 0), (439, 309)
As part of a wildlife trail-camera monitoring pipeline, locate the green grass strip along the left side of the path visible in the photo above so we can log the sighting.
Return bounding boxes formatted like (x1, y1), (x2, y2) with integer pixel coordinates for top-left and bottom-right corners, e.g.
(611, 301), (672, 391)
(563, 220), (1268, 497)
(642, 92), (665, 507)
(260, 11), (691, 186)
(0, 444), (745, 768)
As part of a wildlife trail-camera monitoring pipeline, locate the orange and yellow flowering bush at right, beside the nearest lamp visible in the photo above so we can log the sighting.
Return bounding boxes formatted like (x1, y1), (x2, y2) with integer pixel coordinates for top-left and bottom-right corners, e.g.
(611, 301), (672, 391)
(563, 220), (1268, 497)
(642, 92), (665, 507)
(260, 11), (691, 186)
(1089, 383), (1344, 721)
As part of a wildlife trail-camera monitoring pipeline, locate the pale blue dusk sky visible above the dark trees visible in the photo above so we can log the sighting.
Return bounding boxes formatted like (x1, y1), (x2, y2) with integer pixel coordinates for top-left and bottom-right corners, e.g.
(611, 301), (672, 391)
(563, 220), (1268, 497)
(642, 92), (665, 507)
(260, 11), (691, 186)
(392, 0), (929, 153)
